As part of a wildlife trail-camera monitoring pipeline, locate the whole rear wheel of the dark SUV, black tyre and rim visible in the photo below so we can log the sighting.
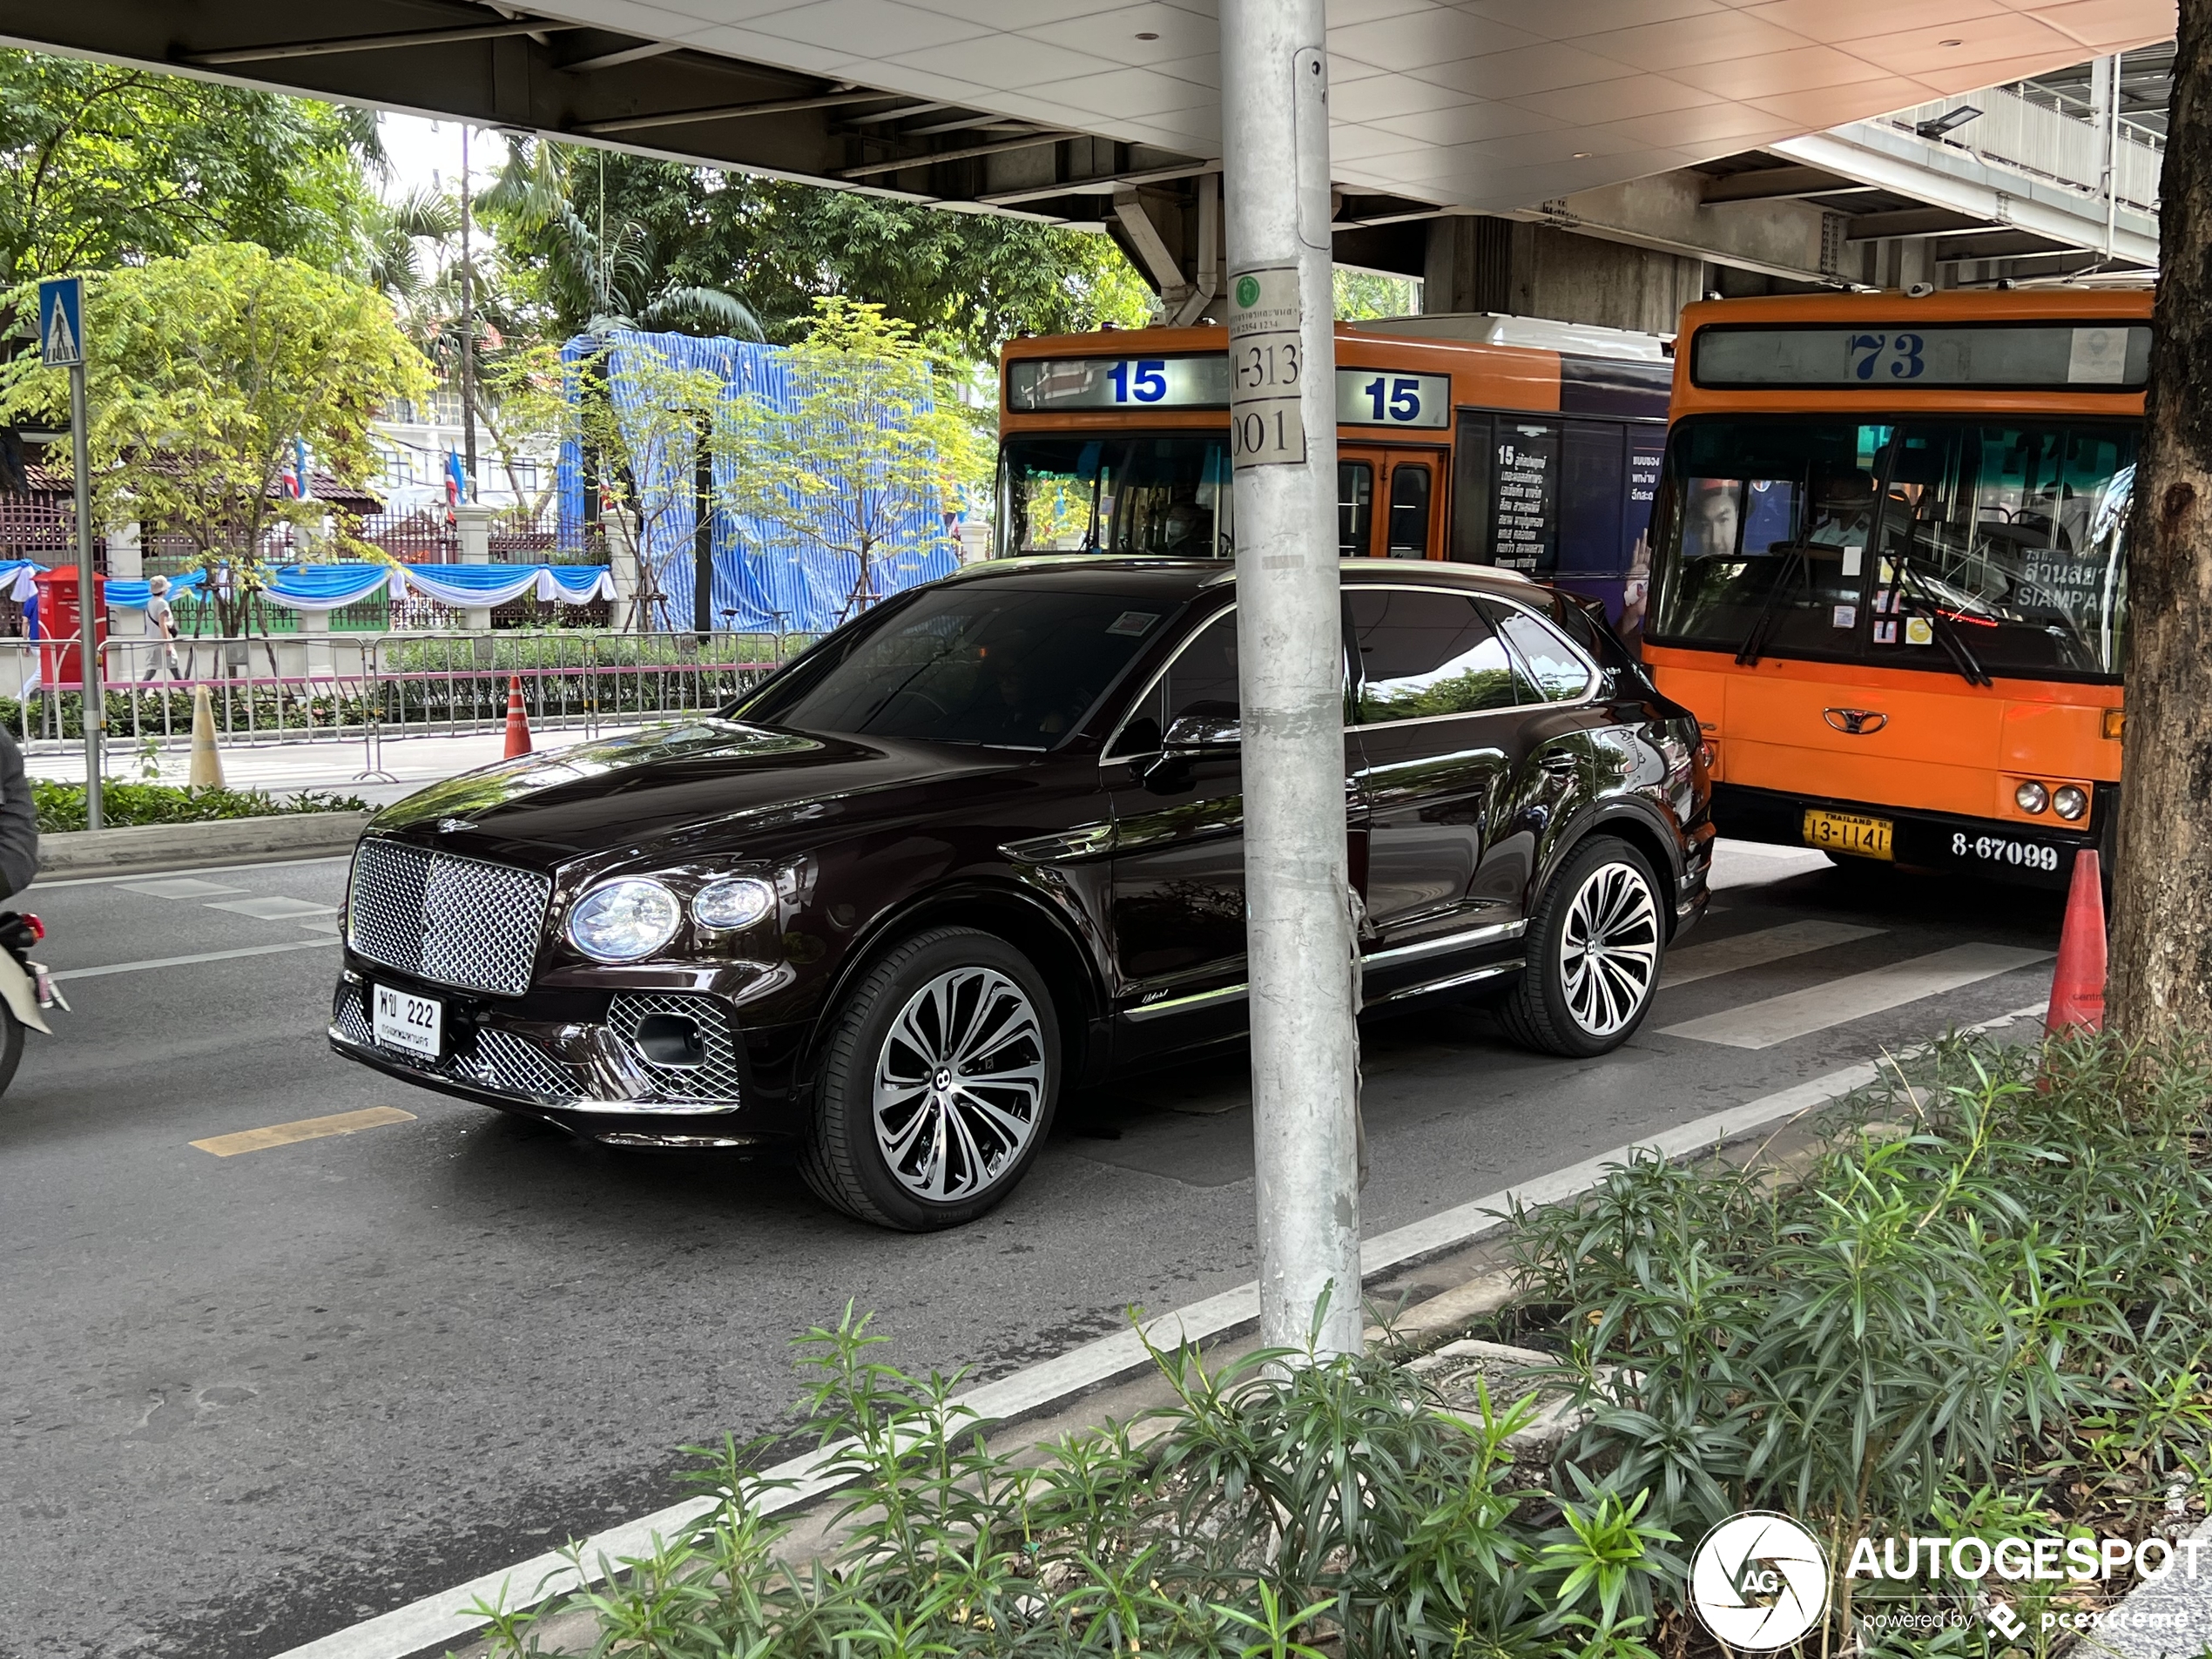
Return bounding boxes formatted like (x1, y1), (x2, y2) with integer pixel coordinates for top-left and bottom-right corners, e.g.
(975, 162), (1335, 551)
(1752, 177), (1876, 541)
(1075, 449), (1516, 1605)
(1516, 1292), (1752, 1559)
(1498, 836), (1666, 1060)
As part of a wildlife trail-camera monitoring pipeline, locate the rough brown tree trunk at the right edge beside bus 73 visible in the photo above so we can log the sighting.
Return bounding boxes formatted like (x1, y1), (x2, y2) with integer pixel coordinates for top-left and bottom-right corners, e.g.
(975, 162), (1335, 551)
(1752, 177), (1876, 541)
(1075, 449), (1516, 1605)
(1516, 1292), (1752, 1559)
(2106, 0), (2212, 1037)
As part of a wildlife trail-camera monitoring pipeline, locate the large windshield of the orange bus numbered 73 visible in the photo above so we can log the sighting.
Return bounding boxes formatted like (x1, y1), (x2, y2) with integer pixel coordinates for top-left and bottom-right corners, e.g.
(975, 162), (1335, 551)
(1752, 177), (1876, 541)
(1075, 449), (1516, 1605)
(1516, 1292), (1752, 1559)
(1648, 416), (2139, 681)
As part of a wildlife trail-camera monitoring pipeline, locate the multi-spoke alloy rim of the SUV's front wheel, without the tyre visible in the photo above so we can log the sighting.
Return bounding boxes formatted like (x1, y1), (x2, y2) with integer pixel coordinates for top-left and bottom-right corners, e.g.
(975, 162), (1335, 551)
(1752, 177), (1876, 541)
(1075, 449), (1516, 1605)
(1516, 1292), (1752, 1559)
(873, 967), (1044, 1204)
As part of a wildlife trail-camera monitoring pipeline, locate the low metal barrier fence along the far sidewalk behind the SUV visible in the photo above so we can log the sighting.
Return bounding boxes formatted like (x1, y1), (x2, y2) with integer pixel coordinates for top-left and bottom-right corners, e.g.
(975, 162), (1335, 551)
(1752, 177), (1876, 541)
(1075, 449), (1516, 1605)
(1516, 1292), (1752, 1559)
(0, 631), (799, 779)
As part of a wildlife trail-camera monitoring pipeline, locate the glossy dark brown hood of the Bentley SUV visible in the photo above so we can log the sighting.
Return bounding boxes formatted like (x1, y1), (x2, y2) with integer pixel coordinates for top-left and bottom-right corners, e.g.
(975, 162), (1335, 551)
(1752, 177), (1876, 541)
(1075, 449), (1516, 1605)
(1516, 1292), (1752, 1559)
(369, 719), (1020, 867)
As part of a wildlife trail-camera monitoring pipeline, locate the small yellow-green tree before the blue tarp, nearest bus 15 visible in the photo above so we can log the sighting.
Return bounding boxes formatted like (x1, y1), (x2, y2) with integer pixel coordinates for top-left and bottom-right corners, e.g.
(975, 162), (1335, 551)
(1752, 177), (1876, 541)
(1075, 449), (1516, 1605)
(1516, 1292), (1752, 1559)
(724, 296), (987, 617)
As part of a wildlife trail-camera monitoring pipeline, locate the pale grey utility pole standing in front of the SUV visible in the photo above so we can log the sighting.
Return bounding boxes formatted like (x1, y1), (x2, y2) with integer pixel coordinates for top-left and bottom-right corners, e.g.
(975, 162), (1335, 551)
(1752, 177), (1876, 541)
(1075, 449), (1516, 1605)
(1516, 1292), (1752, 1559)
(1221, 0), (1365, 1353)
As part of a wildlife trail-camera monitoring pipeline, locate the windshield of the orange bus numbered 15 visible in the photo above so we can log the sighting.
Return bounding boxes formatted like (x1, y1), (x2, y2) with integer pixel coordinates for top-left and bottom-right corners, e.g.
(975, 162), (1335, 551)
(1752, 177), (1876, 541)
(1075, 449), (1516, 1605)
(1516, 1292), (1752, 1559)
(995, 434), (1234, 560)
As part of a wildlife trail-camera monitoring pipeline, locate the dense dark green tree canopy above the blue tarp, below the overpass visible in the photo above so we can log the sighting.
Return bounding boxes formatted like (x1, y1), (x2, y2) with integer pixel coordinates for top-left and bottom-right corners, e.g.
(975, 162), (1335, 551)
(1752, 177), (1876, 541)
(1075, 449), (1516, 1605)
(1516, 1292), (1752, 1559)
(484, 144), (1150, 361)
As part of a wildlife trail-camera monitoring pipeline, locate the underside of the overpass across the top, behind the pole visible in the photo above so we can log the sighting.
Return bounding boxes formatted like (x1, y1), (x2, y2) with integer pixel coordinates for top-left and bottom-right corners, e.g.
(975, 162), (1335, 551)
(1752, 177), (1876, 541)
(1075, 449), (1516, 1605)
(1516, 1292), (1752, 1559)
(0, 0), (2175, 230)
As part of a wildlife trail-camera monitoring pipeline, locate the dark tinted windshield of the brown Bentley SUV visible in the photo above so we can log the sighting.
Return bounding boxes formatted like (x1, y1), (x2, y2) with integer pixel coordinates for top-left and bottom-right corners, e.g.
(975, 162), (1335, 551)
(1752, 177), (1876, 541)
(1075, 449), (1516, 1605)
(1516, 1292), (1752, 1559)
(737, 584), (1177, 750)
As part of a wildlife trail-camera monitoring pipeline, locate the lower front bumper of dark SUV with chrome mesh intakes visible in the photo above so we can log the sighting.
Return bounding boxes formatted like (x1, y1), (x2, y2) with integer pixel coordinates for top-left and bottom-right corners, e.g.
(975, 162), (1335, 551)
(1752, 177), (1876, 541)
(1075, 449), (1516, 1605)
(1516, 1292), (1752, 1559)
(329, 960), (800, 1146)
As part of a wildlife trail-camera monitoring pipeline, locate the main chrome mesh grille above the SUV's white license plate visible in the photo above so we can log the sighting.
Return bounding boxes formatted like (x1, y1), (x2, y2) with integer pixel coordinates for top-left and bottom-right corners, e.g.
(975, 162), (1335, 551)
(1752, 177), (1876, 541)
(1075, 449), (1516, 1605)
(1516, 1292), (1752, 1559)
(345, 836), (553, 995)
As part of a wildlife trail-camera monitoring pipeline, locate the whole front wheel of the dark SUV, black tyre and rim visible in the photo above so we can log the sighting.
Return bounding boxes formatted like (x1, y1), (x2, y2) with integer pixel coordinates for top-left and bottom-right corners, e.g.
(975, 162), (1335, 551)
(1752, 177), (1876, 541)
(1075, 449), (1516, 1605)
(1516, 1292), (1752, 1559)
(799, 927), (1060, 1232)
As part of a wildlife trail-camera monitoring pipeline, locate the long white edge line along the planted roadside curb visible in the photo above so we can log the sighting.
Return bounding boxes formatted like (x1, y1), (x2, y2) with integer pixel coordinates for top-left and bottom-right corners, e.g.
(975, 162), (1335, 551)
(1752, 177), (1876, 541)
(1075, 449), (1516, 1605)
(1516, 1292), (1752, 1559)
(277, 1004), (2041, 1659)
